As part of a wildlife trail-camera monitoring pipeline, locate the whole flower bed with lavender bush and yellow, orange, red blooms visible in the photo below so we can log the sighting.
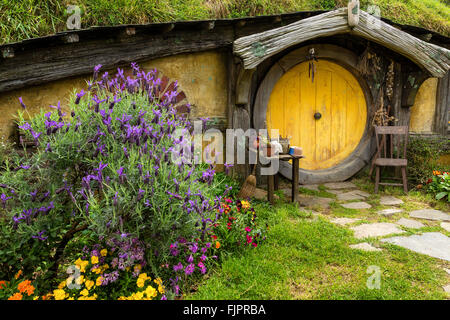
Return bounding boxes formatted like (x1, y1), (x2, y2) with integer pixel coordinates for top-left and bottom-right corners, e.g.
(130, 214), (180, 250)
(0, 64), (264, 299)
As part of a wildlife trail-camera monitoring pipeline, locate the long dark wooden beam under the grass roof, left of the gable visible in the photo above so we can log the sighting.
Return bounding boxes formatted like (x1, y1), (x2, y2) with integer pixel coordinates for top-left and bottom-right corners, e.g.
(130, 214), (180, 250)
(0, 25), (234, 92)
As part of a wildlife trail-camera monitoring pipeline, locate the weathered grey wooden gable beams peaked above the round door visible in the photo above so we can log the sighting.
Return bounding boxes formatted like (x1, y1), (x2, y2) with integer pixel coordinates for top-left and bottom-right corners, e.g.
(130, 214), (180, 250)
(233, 8), (450, 77)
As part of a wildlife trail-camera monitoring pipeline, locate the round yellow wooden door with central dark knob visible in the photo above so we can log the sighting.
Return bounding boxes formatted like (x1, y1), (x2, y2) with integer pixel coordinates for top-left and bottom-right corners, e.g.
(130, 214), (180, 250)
(267, 60), (367, 170)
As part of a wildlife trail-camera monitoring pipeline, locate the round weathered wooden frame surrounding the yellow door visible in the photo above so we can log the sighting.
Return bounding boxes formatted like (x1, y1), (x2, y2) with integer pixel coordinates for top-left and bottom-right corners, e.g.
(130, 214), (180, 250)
(253, 44), (373, 184)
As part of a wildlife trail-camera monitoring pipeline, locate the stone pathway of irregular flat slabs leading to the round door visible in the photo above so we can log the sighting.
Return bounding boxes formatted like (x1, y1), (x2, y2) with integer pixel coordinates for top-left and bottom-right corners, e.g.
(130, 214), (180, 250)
(283, 182), (450, 264)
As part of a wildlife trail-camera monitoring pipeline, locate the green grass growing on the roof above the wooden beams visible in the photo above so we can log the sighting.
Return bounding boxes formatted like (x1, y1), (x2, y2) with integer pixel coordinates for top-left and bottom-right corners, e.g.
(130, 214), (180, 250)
(0, 0), (450, 44)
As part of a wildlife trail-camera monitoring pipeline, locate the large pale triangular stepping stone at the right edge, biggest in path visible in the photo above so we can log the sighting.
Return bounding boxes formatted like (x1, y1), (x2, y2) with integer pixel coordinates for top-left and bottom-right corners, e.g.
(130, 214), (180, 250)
(381, 232), (450, 261)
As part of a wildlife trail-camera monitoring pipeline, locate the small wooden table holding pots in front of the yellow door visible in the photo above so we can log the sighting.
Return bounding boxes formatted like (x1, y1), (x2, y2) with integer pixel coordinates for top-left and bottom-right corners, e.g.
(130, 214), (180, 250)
(252, 150), (305, 204)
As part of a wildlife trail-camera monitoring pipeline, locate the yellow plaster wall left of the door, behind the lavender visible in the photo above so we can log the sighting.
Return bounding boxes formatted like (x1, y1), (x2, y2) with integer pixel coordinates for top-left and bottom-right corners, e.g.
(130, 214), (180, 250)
(0, 51), (228, 138)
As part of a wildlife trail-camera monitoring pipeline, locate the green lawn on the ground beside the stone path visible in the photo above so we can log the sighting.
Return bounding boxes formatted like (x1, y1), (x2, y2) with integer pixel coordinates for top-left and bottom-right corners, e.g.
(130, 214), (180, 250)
(185, 179), (450, 300)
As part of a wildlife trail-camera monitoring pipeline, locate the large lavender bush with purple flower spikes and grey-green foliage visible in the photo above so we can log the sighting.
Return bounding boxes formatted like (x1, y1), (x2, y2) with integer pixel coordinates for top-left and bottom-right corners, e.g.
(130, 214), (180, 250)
(0, 64), (229, 290)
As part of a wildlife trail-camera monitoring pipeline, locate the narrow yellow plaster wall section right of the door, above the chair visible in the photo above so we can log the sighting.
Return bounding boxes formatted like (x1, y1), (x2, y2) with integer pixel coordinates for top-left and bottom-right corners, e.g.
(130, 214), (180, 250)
(410, 78), (438, 133)
